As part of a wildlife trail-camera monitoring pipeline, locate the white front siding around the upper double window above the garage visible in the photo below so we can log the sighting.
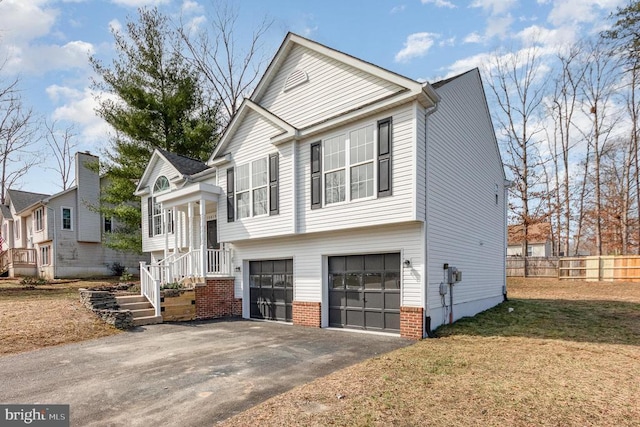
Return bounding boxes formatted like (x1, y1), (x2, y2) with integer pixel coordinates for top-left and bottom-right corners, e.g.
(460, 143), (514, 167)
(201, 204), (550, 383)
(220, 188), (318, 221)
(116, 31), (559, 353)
(297, 105), (417, 233)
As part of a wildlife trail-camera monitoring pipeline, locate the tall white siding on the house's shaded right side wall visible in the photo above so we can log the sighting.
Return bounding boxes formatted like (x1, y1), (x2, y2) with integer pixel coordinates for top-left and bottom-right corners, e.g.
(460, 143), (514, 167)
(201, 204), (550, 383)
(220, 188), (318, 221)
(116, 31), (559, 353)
(426, 72), (506, 327)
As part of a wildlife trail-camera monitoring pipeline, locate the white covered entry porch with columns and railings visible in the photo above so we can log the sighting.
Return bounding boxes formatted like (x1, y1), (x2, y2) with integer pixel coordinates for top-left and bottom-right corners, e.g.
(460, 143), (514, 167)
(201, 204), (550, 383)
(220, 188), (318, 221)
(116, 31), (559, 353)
(140, 182), (232, 316)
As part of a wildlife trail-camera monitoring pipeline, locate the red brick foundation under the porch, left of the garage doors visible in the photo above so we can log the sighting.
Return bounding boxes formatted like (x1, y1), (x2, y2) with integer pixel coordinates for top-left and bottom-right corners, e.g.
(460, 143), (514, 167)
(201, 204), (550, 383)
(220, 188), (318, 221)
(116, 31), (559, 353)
(196, 277), (242, 320)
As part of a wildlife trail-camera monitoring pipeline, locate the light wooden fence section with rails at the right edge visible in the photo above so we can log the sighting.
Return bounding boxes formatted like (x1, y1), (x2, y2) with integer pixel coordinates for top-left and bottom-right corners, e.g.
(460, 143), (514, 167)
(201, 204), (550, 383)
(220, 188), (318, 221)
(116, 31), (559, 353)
(558, 255), (640, 282)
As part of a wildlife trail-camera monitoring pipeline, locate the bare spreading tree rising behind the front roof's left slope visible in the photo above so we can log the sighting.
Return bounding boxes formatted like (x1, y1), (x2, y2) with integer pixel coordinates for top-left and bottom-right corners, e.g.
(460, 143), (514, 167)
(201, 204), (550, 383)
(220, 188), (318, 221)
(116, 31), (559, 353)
(179, 0), (273, 123)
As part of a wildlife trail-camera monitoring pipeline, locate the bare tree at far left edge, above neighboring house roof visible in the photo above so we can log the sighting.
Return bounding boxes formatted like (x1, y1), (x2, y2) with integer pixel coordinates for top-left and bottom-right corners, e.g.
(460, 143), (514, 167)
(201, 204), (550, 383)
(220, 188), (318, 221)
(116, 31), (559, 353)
(0, 75), (40, 203)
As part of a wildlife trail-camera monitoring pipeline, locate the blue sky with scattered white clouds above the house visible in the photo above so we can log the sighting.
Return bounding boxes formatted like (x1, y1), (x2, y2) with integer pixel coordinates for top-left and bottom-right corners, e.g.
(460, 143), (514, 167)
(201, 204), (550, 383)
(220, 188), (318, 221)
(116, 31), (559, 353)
(0, 0), (626, 194)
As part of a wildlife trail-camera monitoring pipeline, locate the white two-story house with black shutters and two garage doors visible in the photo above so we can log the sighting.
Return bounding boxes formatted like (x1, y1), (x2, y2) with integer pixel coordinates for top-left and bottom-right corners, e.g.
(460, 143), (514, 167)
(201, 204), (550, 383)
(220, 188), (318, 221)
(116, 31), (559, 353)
(136, 33), (506, 338)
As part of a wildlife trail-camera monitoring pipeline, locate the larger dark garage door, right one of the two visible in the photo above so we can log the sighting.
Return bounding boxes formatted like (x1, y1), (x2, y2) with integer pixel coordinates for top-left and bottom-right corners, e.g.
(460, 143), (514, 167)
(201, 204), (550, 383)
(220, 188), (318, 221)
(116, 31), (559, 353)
(329, 253), (400, 332)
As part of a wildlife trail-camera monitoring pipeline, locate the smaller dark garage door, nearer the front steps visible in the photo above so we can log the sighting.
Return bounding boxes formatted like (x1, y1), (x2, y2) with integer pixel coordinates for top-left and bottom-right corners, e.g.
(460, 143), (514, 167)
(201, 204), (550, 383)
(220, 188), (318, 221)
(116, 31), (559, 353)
(249, 259), (293, 322)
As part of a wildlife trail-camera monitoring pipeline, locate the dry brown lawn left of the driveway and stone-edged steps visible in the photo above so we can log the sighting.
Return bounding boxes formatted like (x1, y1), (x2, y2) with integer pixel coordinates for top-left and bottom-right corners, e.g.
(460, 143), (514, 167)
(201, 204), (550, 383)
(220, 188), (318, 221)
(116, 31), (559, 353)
(0, 279), (119, 355)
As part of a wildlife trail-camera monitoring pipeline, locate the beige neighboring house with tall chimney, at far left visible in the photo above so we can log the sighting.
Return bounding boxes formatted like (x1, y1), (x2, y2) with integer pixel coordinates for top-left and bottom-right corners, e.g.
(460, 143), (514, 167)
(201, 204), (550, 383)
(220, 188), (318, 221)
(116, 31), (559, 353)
(0, 153), (148, 279)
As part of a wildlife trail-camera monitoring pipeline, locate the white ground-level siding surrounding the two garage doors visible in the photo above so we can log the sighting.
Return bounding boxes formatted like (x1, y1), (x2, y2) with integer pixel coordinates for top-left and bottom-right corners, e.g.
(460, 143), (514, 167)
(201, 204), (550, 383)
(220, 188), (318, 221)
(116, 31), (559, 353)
(232, 223), (424, 326)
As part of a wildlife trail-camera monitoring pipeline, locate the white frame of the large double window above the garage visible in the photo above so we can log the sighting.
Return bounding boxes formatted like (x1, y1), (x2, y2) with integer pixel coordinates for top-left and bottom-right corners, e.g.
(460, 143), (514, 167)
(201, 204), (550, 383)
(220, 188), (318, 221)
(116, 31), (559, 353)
(321, 121), (378, 207)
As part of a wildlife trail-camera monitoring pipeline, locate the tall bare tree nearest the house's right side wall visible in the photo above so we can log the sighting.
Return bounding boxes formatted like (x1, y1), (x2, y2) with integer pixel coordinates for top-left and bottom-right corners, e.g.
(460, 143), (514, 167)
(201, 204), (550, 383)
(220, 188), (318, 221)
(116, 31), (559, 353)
(488, 48), (547, 255)
